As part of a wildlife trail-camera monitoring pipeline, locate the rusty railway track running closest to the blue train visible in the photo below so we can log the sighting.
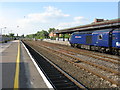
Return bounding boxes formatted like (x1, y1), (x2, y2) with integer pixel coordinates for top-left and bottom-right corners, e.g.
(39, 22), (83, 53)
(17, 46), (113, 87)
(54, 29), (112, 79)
(34, 43), (120, 71)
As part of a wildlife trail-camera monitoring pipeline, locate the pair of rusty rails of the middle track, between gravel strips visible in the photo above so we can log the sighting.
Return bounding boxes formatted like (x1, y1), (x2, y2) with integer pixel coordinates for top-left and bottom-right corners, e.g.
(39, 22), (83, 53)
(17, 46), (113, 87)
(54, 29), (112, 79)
(38, 46), (119, 85)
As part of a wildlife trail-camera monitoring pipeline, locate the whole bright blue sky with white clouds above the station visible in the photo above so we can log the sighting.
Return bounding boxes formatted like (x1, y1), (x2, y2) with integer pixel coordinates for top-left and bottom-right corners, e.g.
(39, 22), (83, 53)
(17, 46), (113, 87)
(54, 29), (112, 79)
(0, 2), (118, 35)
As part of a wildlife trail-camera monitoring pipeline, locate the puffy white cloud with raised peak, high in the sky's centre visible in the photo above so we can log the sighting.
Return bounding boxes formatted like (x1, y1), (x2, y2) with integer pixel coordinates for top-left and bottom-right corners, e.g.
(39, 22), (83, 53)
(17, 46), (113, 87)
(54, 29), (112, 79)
(19, 6), (70, 23)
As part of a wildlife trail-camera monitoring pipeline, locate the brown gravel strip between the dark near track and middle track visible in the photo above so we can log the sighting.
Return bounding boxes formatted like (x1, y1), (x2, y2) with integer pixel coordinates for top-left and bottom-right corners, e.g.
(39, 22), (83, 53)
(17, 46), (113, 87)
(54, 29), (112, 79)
(23, 42), (118, 88)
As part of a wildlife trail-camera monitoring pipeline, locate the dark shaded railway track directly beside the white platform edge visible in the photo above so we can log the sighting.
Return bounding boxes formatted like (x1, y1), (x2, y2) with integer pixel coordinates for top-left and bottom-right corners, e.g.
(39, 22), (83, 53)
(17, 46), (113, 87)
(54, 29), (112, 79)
(24, 43), (88, 90)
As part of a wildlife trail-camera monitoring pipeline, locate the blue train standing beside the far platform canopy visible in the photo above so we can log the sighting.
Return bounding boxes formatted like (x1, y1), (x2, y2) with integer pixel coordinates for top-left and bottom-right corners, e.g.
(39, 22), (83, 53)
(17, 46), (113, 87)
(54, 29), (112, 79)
(69, 28), (120, 55)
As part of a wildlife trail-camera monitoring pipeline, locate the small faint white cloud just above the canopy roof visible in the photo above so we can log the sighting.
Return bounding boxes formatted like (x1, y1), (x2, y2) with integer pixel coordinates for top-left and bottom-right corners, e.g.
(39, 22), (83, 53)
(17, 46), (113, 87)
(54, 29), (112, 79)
(56, 16), (89, 29)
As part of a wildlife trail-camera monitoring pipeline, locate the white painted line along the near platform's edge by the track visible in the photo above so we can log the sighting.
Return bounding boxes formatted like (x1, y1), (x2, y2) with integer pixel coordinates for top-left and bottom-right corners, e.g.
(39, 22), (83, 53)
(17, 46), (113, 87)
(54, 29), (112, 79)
(22, 43), (54, 90)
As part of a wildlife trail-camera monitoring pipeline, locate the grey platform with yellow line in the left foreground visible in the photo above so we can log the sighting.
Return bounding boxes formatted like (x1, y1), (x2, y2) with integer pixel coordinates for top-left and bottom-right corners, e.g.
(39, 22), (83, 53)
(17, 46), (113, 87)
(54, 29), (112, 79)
(0, 40), (50, 89)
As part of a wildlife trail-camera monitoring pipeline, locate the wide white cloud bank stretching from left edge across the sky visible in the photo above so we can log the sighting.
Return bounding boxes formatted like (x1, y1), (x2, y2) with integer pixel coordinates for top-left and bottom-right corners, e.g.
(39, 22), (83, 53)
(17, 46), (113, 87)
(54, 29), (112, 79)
(0, 6), (89, 35)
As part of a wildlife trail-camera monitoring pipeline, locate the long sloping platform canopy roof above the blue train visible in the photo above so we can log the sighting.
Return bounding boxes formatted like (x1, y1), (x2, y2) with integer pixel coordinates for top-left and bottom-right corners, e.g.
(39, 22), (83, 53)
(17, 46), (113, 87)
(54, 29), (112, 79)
(54, 18), (120, 34)
